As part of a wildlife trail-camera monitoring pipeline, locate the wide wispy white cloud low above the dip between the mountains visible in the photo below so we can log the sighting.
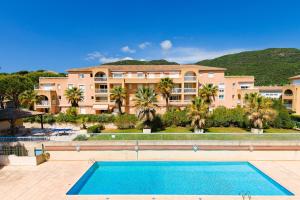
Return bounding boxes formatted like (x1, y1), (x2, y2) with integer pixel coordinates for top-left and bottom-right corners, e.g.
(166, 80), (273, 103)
(164, 47), (245, 64)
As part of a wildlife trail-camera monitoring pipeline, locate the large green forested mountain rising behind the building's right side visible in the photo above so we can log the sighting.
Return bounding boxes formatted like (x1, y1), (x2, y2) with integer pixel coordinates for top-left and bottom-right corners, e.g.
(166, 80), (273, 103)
(196, 48), (300, 85)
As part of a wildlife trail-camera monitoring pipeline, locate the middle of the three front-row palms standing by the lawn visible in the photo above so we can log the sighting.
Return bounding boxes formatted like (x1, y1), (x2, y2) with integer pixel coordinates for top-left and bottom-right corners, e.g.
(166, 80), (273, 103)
(188, 97), (209, 132)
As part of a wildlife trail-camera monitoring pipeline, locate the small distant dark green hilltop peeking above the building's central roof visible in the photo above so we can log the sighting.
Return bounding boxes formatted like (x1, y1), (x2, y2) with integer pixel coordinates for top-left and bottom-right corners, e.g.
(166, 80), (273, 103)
(103, 60), (178, 65)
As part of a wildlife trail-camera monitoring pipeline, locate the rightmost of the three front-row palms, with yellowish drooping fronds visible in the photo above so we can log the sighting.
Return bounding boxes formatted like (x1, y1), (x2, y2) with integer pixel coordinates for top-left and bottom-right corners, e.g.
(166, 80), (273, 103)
(245, 93), (276, 133)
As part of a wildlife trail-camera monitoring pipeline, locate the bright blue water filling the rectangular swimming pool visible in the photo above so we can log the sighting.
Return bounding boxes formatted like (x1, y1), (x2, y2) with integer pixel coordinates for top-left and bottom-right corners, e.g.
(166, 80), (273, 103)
(67, 162), (293, 196)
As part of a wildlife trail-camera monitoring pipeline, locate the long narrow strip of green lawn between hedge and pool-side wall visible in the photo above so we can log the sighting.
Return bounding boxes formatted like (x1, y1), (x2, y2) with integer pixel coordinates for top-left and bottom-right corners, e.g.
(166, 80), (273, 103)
(89, 133), (300, 140)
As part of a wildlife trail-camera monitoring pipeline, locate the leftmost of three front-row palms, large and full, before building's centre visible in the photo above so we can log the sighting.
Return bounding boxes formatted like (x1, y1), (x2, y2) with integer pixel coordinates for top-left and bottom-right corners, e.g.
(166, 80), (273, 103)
(134, 87), (157, 128)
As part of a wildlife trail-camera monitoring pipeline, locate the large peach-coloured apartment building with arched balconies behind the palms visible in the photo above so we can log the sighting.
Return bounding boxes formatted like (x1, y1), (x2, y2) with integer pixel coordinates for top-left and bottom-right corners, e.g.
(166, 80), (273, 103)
(35, 65), (256, 114)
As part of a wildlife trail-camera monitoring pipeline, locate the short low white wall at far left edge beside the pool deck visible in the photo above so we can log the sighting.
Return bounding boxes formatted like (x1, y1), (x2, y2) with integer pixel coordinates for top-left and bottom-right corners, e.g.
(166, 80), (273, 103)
(0, 155), (37, 166)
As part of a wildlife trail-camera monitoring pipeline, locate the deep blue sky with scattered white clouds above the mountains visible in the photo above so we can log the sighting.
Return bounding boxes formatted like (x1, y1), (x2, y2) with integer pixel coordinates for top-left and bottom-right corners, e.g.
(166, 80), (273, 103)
(0, 0), (300, 72)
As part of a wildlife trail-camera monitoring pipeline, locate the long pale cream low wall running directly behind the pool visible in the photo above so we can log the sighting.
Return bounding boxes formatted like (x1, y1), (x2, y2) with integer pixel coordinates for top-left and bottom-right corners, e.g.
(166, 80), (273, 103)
(49, 150), (300, 161)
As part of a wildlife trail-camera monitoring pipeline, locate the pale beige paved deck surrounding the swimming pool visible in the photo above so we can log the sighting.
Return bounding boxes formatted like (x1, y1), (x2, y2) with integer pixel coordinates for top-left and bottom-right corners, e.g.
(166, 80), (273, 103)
(0, 161), (300, 200)
